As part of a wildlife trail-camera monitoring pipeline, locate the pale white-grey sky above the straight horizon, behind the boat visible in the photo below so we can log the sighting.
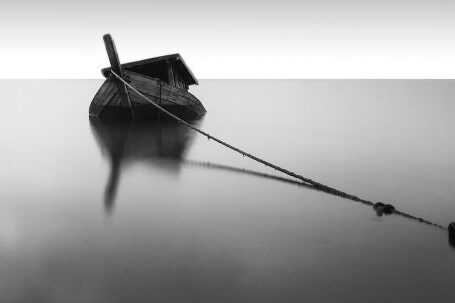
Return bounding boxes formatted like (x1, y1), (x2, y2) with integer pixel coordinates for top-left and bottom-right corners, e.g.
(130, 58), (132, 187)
(0, 0), (455, 79)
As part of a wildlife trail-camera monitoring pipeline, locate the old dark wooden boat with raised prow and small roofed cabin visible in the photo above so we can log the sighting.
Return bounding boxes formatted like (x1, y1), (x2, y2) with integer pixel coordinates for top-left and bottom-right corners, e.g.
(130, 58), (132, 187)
(89, 34), (206, 120)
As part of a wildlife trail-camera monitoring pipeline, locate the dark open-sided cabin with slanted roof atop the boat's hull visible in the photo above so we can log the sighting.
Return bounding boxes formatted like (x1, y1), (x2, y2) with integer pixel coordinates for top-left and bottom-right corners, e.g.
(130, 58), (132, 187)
(102, 54), (198, 90)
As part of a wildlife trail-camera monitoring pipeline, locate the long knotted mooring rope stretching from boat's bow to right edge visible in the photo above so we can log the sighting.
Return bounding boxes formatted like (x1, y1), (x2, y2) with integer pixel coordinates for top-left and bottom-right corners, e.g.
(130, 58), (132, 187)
(110, 70), (447, 230)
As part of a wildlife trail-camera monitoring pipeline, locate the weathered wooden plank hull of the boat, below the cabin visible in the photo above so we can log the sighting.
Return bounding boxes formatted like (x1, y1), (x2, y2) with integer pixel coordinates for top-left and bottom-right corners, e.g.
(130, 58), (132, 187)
(89, 70), (206, 120)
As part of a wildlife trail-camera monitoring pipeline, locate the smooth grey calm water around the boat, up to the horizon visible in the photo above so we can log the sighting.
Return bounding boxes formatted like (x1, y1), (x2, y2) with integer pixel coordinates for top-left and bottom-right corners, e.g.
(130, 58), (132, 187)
(0, 80), (455, 302)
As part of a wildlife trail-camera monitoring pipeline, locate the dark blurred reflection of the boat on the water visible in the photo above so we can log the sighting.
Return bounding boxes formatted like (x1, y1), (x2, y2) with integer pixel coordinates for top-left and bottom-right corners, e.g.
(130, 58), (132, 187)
(90, 117), (201, 213)
